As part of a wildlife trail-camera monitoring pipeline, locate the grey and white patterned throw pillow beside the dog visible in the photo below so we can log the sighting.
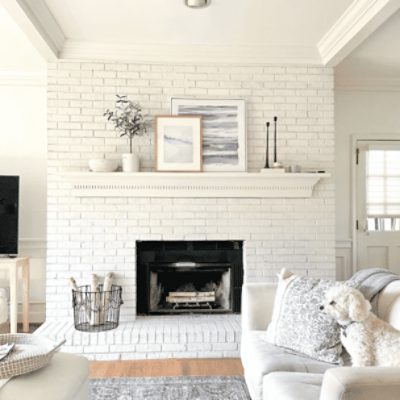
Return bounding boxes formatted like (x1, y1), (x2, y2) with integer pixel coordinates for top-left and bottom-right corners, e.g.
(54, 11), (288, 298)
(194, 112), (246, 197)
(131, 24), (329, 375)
(266, 270), (342, 363)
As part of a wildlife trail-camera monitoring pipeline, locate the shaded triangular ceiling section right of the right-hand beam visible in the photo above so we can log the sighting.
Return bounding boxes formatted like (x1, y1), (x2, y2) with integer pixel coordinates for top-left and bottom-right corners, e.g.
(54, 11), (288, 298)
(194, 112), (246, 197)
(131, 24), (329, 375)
(335, 11), (400, 84)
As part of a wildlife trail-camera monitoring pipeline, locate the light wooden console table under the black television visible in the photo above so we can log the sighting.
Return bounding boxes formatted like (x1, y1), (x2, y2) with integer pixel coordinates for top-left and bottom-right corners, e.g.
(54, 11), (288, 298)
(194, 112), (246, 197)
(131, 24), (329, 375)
(0, 257), (29, 333)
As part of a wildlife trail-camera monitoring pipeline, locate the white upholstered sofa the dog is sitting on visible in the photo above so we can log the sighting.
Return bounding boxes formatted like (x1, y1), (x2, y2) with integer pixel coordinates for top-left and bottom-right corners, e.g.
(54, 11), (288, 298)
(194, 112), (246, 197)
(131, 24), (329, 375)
(241, 281), (400, 400)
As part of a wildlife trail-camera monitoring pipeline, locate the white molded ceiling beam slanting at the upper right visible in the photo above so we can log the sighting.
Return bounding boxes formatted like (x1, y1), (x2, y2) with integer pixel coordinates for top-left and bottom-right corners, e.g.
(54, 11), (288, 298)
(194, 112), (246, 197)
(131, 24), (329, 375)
(317, 0), (400, 66)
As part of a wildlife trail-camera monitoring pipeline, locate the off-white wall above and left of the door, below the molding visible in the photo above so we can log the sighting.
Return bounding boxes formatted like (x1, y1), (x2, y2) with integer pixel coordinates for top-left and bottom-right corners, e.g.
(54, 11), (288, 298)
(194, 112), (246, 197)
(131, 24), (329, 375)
(335, 87), (400, 274)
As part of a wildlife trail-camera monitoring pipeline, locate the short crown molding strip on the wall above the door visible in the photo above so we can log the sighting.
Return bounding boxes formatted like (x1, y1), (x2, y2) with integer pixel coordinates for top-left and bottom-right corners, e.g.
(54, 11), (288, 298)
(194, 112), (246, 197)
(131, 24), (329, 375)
(335, 76), (400, 92)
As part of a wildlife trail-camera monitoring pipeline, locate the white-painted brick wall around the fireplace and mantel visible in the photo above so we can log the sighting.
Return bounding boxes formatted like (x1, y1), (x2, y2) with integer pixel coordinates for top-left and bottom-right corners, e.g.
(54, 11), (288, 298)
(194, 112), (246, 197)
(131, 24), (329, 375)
(47, 61), (335, 322)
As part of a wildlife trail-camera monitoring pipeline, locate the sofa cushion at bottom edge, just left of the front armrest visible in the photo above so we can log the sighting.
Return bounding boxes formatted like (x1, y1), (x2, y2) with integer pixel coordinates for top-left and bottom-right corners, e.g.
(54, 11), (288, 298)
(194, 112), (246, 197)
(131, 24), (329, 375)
(263, 372), (324, 400)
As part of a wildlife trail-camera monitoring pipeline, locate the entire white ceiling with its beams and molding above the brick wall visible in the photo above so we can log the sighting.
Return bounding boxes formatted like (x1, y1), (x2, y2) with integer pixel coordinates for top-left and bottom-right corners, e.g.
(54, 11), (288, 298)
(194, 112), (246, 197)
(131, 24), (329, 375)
(0, 0), (400, 75)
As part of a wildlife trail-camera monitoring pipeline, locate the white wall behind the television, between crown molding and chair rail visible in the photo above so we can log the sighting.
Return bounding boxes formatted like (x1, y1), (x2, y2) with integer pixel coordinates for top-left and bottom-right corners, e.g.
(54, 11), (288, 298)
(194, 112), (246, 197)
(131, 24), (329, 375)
(0, 85), (47, 240)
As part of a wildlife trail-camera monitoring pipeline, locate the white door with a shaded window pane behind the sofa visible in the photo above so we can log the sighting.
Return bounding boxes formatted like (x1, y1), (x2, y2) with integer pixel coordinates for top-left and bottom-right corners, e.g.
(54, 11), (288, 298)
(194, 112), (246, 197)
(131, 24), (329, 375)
(356, 140), (400, 274)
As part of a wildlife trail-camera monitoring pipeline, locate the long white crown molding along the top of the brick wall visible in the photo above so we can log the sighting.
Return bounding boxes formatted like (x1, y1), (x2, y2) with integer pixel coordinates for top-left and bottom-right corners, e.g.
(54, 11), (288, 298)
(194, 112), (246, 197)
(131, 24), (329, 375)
(60, 40), (322, 65)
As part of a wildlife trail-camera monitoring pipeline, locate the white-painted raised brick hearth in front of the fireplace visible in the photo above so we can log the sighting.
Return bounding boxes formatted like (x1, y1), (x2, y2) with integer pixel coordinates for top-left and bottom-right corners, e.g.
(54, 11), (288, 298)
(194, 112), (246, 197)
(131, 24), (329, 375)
(36, 315), (241, 360)
